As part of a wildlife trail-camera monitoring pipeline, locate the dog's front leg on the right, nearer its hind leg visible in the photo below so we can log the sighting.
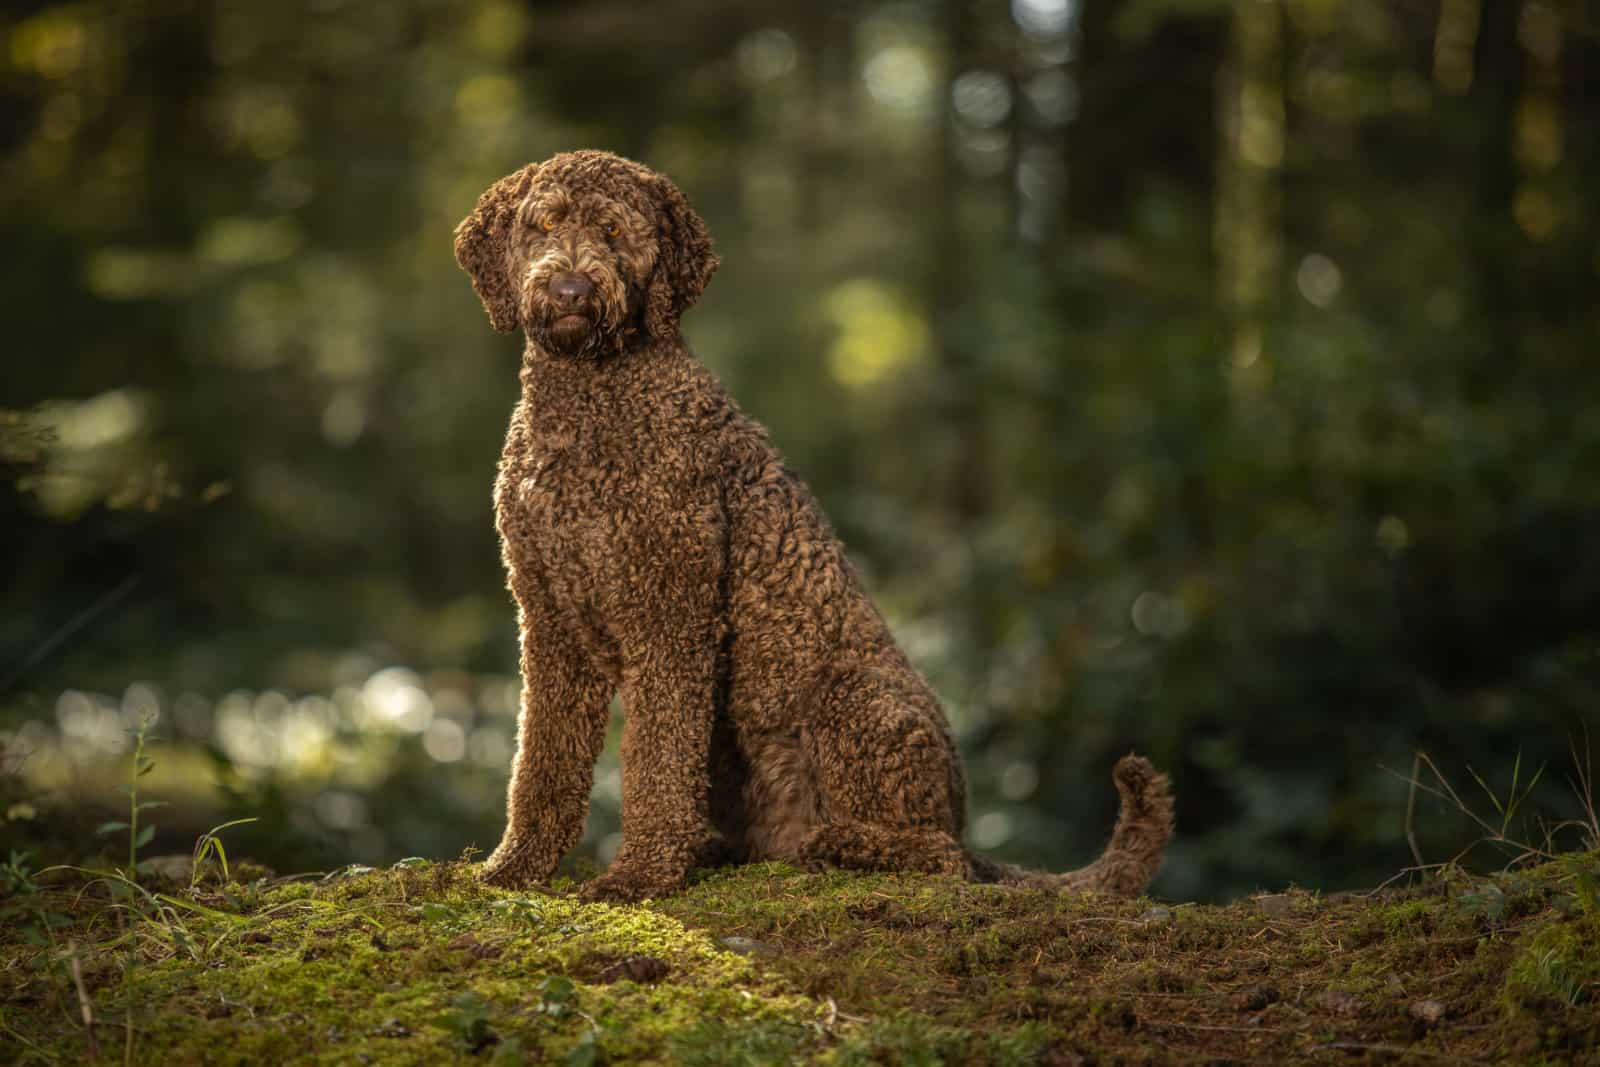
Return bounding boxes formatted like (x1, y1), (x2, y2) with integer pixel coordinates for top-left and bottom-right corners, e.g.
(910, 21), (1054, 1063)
(581, 514), (722, 901)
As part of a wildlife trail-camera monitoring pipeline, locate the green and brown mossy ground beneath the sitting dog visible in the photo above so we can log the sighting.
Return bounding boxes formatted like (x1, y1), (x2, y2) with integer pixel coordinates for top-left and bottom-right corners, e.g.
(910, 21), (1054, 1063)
(0, 853), (1600, 1064)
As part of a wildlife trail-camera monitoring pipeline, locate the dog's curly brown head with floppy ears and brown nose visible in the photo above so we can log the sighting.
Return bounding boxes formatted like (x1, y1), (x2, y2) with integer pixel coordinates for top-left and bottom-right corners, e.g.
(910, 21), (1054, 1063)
(456, 150), (717, 355)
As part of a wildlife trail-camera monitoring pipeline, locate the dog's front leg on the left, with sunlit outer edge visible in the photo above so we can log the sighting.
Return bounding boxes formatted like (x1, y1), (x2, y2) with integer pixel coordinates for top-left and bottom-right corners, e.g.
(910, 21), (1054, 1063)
(482, 587), (613, 886)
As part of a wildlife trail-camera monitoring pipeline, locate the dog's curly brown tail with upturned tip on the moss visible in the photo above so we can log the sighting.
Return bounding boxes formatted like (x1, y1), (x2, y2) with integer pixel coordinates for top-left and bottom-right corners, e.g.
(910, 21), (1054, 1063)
(971, 752), (1173, 896)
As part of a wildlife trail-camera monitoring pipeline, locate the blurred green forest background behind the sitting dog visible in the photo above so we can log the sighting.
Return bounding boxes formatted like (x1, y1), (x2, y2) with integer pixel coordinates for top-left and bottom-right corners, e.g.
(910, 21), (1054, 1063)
(0, 0), (1600, 899)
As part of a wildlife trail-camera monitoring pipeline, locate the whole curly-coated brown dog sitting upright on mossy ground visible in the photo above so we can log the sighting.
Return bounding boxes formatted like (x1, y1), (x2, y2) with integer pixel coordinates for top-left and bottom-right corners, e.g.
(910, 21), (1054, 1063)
(456, 152), (1173, 901)
